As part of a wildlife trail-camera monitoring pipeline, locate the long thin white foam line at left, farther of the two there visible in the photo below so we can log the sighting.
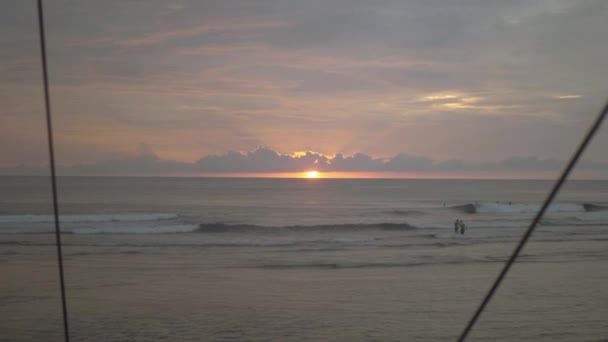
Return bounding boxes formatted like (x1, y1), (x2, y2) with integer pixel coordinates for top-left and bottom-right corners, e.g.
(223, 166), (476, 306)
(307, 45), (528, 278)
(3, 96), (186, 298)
(0, 213), (177, 224)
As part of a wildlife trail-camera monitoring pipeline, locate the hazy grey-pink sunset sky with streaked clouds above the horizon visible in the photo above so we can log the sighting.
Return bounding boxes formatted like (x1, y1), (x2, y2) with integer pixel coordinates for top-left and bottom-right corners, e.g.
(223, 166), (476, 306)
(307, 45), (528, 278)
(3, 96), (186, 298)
(0, 0), (608, 179)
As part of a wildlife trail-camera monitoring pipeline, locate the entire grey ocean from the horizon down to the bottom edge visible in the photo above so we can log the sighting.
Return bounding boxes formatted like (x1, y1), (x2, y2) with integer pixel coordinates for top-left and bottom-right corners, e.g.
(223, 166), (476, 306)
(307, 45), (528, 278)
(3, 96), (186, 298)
(0, 177), (608, 341)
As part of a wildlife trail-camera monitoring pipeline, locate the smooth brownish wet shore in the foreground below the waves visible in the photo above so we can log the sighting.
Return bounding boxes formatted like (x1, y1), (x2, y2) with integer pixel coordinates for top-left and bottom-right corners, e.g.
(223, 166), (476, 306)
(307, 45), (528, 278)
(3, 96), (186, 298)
(0, 241), (608, 342)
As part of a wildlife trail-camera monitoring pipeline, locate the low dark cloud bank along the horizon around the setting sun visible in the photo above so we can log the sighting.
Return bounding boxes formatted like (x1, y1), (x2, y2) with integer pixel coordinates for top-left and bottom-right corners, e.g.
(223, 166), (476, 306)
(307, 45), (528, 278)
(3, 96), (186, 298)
(0, 148), (608, 178)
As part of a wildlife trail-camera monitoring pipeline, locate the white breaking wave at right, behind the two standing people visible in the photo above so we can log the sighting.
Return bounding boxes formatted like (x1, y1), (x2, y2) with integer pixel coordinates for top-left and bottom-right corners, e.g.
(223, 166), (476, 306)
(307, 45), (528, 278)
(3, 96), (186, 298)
(450, 202), (608, 214)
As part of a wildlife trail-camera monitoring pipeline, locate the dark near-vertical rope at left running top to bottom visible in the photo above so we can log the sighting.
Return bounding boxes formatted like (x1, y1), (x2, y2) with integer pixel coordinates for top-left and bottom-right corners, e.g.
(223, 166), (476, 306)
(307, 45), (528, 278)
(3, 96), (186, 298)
(38, 0), (70, 342)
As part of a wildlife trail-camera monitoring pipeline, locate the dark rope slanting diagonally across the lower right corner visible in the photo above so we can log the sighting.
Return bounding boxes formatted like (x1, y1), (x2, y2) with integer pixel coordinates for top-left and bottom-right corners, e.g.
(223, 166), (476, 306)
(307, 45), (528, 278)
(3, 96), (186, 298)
(458, 98), (608, 342)
